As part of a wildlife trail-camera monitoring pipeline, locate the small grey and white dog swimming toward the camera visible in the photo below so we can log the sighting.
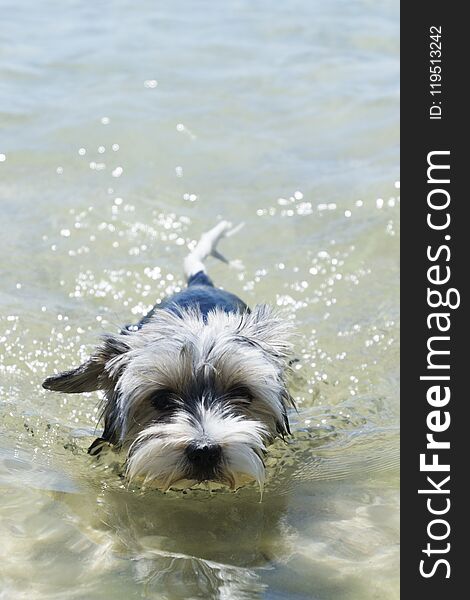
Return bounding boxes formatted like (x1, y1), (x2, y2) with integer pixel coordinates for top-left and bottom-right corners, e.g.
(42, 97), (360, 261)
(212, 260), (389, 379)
(43, 221), (294, 491)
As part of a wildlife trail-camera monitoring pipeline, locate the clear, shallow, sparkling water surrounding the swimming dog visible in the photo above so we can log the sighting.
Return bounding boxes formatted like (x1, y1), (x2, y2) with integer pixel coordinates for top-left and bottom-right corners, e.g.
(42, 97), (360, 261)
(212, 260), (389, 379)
(0, 0), (400, 600)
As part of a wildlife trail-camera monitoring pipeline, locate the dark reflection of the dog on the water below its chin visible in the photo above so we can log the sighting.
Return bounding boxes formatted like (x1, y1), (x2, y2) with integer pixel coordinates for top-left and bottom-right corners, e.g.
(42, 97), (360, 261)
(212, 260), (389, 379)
(62, 488), (289, 598)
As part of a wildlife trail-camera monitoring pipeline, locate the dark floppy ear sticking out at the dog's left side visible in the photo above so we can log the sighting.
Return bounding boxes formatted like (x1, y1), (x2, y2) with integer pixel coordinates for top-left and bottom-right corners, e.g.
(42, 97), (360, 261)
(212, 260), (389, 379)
(42, 335), (129, 394)
